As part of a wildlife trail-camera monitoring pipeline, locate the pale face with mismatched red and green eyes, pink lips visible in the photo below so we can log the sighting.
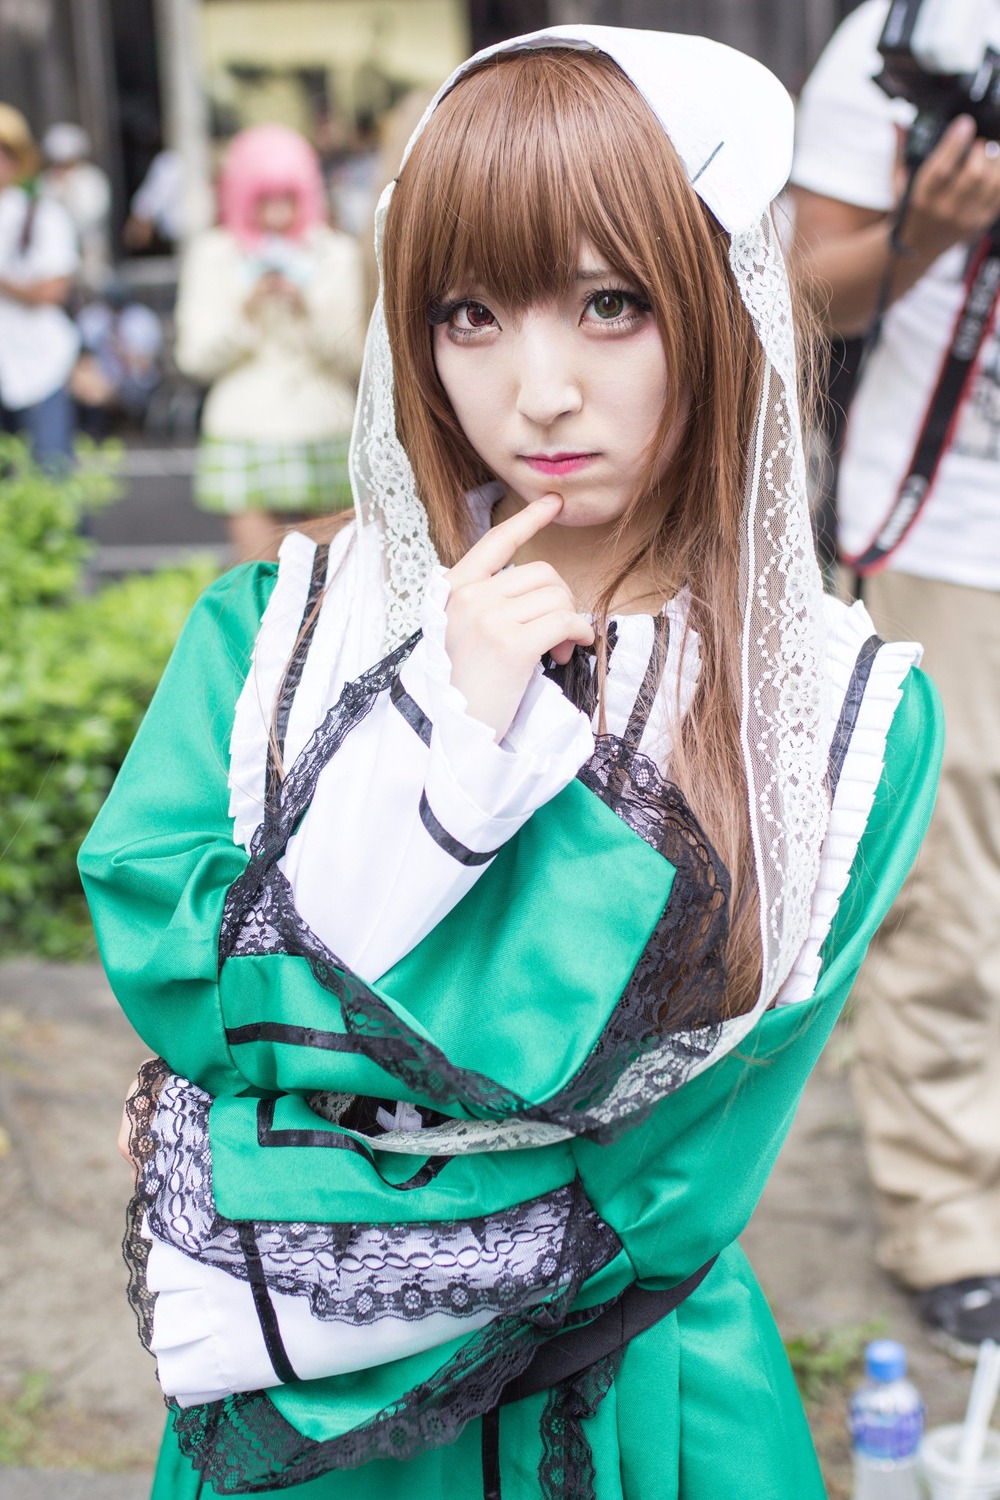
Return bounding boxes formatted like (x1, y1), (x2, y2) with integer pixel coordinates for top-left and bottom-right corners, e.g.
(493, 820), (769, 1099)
(430, 245), (667, 527)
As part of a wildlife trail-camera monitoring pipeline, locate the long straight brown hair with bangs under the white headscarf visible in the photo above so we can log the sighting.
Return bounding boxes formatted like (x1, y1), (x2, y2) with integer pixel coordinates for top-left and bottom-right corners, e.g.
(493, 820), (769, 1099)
(382, 48), (763, 1014)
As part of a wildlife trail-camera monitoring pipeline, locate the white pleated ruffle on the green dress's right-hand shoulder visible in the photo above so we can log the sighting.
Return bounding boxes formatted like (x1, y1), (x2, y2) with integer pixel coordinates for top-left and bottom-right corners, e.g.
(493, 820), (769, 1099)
(775, 599), (922, 1005)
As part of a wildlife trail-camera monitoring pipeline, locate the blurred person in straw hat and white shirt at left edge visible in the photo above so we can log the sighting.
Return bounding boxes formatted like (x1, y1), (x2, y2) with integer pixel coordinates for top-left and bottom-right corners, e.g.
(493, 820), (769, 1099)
(0, 105), (79, 467)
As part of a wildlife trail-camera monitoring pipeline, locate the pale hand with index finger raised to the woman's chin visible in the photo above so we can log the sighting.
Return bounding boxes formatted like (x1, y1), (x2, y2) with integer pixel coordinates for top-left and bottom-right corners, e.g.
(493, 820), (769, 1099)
(445, 495), (594, 743)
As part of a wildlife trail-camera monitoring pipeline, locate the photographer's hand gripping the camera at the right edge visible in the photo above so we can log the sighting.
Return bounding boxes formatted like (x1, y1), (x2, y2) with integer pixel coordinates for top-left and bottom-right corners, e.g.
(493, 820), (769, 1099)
(900, 114), (1000, 260)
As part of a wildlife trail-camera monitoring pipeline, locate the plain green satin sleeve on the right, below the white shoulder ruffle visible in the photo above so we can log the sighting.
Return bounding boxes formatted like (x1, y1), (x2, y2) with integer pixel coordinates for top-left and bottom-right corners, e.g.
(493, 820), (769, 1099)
(573, 671), (943, 1286)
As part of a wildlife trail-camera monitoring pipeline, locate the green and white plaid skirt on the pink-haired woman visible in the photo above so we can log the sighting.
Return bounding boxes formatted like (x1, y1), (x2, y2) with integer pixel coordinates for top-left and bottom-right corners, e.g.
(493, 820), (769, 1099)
(195, 434), (352, 516)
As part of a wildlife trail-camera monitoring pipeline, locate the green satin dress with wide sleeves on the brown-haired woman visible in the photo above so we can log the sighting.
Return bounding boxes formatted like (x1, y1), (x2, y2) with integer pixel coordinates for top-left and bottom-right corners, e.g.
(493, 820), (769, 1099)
(81, 566), (942, 1500)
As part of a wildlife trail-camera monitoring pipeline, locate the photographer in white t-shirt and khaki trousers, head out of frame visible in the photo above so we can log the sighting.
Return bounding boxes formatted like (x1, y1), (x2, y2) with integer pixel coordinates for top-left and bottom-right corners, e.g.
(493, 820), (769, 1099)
(792, 0), (1000, 1358)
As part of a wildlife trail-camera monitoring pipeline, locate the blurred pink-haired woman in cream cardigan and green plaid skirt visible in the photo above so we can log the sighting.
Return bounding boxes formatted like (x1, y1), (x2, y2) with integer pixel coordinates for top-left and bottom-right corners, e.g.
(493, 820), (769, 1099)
(177, 125), (363, 560)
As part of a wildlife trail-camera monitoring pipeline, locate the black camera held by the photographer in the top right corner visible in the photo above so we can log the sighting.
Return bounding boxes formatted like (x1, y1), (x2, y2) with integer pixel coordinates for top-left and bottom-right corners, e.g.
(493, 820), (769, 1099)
(876, 0), (1000, 170)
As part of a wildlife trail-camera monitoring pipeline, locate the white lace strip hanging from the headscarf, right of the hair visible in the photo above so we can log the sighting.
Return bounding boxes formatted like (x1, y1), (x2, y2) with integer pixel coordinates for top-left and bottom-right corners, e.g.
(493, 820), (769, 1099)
(730, 213), (829, 1016)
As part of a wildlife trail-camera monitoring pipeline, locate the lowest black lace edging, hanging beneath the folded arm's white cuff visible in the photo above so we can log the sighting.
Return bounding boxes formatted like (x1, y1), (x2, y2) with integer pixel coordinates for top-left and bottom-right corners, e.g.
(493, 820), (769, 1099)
(172, 1187), (612, 1496)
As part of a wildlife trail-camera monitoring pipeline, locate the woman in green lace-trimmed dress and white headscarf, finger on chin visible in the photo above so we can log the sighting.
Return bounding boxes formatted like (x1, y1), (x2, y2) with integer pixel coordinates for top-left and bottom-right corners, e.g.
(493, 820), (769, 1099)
(81, 27), (940, 1500)
